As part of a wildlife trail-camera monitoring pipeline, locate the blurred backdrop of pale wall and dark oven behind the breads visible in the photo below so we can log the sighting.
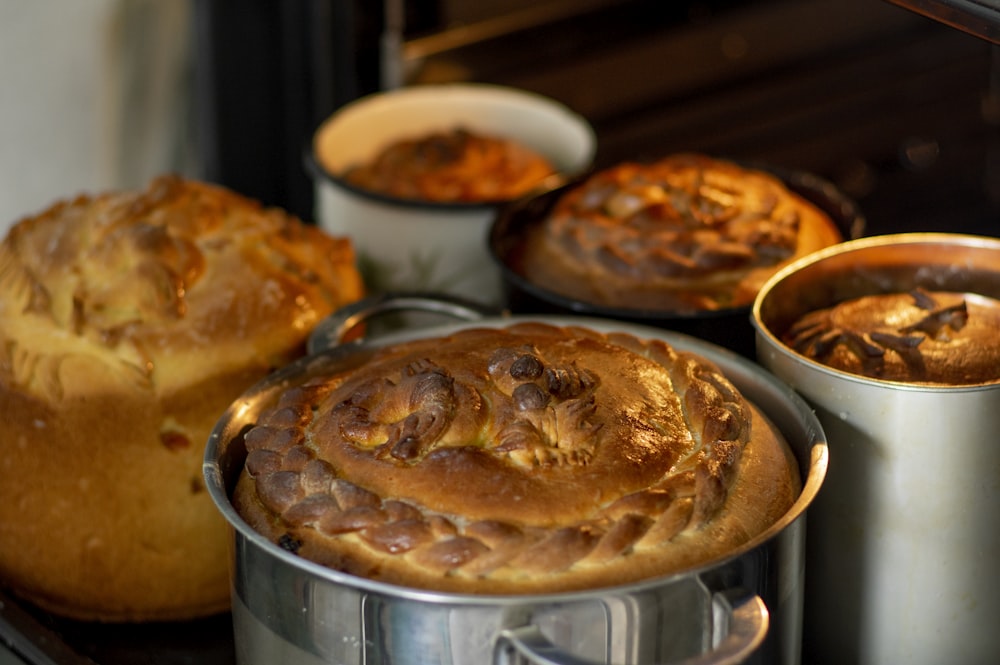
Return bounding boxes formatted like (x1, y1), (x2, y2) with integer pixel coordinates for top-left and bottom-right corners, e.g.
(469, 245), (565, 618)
(0, 0), (1000, 235)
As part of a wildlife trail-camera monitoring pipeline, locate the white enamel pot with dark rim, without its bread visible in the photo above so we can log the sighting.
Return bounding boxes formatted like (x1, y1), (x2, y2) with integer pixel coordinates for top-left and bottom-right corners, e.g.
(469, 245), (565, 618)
(306, 83), (597, 305)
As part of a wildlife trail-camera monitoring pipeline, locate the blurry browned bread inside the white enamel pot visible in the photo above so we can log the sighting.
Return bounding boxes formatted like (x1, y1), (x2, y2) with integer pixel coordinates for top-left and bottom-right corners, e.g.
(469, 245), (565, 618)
(345, 127), (555, 203)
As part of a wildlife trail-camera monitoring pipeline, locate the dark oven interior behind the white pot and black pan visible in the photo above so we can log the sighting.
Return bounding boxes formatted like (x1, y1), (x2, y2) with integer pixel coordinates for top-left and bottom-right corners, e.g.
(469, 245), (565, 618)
(198, 0), (1000, 235)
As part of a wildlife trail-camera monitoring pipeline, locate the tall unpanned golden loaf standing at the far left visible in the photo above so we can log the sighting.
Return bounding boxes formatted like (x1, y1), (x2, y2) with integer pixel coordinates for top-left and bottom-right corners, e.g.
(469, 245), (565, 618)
(0, 176), (362, 621)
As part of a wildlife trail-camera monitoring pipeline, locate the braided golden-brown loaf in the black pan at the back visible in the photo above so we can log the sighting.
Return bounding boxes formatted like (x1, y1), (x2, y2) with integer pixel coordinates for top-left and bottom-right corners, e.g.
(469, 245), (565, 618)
(522, 154), (843, 311)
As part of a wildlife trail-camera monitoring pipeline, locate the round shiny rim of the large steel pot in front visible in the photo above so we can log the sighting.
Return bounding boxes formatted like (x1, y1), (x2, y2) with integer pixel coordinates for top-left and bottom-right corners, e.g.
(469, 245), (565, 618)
(203, 314), (829, 606)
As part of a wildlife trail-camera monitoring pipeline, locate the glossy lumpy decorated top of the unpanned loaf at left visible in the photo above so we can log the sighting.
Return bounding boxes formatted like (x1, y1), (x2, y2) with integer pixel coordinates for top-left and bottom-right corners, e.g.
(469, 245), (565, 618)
(0, 176), (362, 397)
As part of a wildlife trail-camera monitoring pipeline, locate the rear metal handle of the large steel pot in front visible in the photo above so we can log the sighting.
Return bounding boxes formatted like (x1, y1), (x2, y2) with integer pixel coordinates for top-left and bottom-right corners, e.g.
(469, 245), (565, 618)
(307, 291), (502, 355)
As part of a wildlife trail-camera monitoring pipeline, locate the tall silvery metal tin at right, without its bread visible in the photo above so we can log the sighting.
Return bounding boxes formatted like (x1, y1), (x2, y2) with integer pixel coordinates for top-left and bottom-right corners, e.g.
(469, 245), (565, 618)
(753, 233), (1000, 665)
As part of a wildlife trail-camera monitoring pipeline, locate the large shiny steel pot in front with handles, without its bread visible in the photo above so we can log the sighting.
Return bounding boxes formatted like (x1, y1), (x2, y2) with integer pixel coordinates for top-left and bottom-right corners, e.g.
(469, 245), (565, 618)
(205, 294), (827, 665)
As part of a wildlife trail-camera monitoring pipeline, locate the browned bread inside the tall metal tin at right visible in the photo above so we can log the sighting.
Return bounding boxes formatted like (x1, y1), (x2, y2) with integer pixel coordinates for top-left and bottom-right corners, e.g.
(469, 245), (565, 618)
(783, 288), (1000, 386)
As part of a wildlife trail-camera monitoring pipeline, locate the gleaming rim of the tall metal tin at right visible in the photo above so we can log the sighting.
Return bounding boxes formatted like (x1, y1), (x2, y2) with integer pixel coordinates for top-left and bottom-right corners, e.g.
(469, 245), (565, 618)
(751, 232), (1000, 394)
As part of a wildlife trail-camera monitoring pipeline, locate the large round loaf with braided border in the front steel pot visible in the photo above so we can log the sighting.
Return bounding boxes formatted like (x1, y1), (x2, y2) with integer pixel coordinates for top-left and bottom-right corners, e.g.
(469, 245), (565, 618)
(233, 322), (801, 594)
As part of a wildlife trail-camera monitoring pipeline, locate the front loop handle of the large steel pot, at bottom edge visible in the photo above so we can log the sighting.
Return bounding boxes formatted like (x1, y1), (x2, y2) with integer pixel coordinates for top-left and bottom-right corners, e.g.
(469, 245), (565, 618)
(493, 592), (770, 665)
